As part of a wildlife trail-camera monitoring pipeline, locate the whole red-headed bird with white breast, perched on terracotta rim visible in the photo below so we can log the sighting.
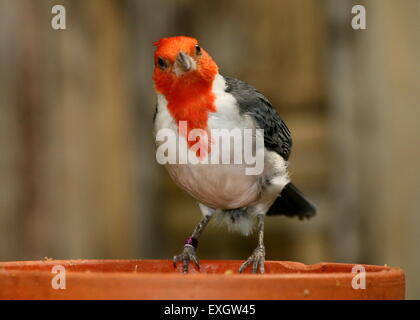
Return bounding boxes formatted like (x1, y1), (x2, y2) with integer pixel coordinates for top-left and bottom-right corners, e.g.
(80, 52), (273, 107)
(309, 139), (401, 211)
(152, 36), (316, 274)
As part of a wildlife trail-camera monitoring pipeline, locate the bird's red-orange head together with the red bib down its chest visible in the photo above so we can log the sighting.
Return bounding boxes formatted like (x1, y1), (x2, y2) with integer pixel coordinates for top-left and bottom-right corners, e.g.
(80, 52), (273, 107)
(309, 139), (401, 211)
(153, 36), (218, 156)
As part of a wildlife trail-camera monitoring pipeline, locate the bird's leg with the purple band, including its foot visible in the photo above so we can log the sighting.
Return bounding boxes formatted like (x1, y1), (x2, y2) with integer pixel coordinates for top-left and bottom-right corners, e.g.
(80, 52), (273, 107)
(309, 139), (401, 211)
(173, 215), (211, 273)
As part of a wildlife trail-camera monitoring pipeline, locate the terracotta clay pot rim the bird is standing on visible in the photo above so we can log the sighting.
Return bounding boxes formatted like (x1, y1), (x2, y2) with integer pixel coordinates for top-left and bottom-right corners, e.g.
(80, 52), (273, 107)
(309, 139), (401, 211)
(0, 260), (405, 300)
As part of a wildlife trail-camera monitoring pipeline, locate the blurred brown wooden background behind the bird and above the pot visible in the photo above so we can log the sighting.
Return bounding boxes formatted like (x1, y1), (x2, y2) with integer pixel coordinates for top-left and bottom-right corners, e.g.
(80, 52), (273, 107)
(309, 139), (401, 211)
(0, 0), (420, 298)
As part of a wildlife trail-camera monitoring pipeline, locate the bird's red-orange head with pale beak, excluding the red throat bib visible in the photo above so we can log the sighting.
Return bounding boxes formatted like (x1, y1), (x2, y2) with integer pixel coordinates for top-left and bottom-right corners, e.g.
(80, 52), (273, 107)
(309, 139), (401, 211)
(153, 36), (218, 96)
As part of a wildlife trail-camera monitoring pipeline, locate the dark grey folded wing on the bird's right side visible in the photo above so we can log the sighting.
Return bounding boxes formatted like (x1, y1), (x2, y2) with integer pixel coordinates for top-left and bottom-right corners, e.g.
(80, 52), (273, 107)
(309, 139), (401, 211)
(224, 77), (292, 160)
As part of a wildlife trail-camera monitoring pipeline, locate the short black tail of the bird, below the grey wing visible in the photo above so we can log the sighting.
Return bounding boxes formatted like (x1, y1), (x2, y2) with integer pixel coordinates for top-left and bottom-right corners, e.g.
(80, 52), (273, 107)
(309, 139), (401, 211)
(267, 182), (316, 220)
